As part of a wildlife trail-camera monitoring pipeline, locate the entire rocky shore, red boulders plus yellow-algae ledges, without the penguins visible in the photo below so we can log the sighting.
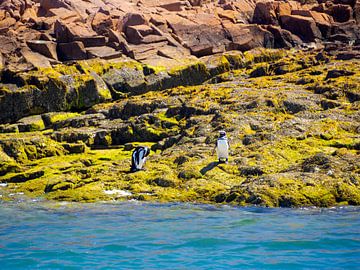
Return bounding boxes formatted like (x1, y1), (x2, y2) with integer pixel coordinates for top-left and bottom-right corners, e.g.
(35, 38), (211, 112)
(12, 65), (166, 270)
(0, 0), (360, 207)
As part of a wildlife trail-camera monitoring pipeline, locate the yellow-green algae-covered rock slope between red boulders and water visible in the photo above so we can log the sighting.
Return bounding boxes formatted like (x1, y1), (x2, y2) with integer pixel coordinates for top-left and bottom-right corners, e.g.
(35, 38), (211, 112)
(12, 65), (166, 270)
(0, 51), (360, 207)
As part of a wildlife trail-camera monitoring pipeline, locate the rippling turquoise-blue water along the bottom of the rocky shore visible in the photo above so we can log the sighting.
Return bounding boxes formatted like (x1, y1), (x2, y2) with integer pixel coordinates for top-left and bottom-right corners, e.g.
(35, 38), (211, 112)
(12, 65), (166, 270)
(0, 199), (360, 269)
